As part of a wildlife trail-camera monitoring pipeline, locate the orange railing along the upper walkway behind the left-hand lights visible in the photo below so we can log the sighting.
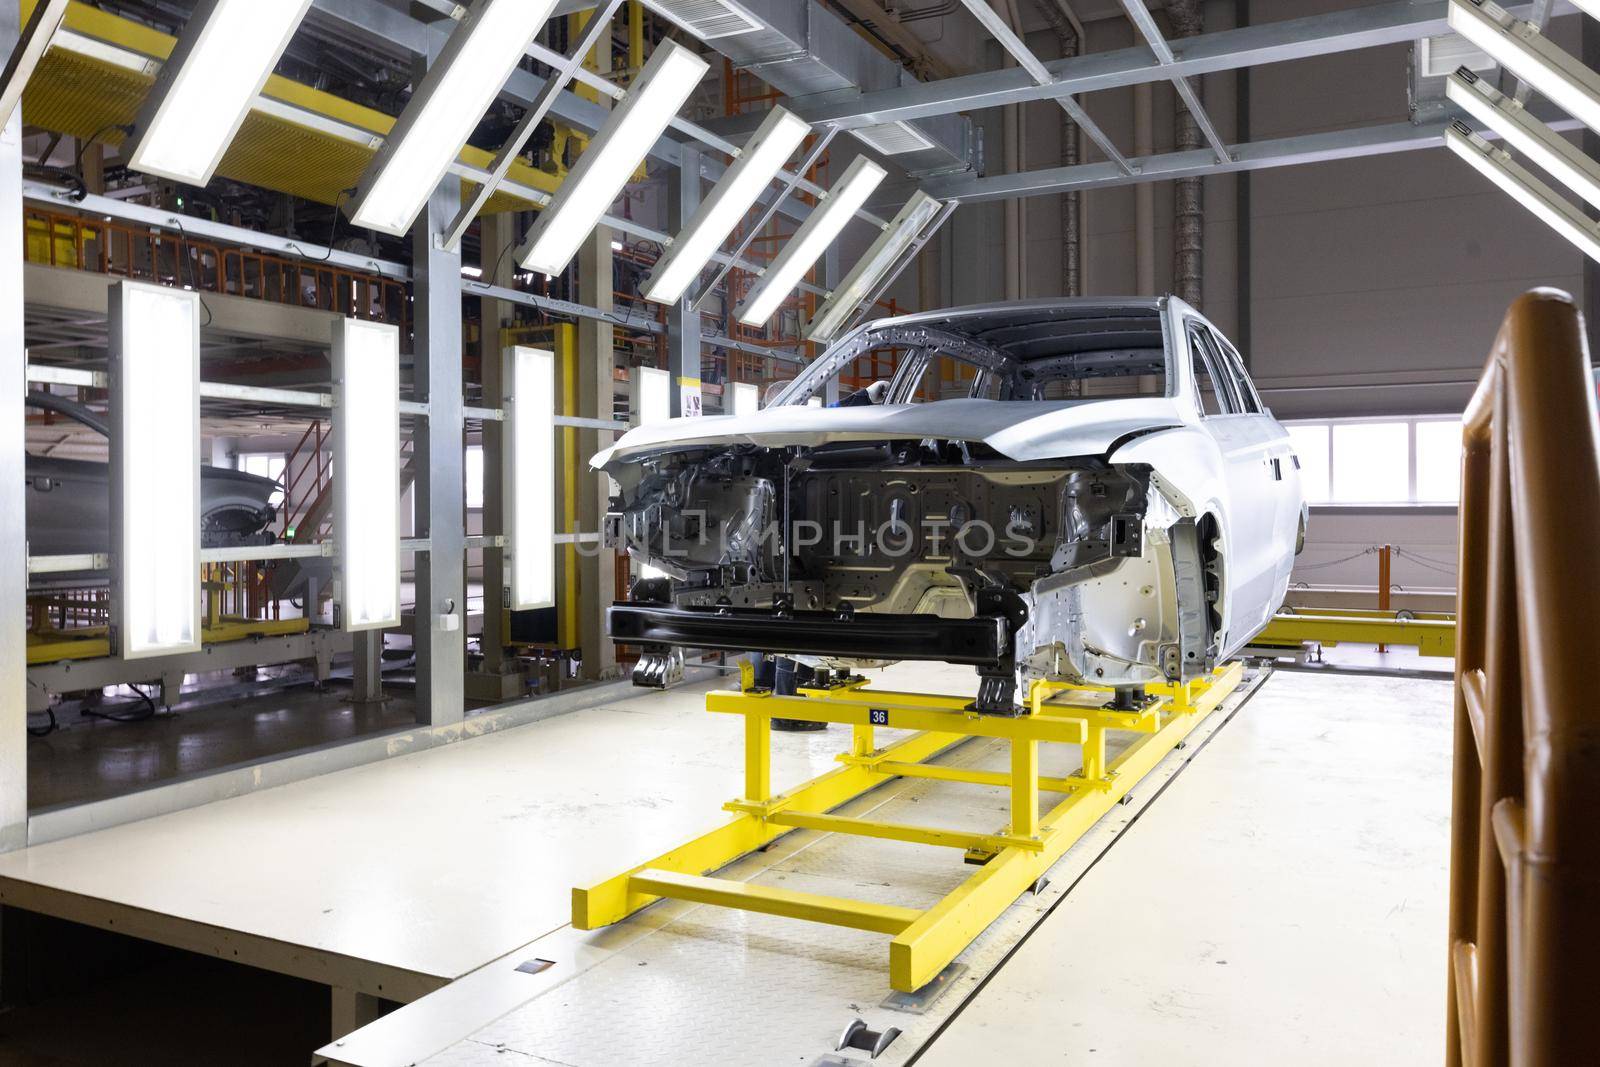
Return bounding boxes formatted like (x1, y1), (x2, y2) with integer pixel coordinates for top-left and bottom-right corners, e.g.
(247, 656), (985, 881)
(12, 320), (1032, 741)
(22, 206), (411, 330)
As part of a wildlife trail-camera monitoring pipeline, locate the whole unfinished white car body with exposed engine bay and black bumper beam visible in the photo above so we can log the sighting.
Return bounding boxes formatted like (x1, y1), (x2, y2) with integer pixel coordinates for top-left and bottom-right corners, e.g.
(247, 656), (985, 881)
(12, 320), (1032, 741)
(594, 298), (1306, 712)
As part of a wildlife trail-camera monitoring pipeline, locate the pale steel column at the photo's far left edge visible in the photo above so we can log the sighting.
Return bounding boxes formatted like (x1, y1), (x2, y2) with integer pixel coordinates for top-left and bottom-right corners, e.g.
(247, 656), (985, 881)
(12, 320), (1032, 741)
(0, 3), (27, 851)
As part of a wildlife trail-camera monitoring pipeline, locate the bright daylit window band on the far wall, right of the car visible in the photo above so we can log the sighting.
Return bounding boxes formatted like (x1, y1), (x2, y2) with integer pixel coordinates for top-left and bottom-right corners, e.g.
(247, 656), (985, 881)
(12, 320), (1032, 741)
(1285, 416), (1461, 506)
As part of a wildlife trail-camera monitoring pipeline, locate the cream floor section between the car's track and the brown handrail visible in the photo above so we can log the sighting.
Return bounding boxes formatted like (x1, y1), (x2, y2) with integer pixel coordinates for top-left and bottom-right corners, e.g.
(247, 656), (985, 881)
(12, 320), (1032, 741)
(918, 672), (1451, 1067)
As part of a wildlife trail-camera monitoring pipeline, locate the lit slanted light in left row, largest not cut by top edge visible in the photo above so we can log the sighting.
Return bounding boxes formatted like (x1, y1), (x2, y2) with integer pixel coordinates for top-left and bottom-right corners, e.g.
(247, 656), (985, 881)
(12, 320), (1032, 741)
(517, 40), (707, 274)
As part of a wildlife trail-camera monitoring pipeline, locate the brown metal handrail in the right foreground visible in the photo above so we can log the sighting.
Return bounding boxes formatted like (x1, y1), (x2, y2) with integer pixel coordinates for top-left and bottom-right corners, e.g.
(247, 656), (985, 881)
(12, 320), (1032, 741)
(1446, 290), (1600, 1067)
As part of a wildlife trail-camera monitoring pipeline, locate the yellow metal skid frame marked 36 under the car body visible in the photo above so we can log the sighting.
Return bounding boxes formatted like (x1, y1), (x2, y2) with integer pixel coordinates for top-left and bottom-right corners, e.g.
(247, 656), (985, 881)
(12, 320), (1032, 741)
(573, 664), (1243, 992)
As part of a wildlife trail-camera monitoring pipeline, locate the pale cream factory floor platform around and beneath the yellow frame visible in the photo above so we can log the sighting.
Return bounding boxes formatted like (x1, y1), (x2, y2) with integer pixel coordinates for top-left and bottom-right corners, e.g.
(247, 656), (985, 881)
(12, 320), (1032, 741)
(0, 665), (1450, 1067)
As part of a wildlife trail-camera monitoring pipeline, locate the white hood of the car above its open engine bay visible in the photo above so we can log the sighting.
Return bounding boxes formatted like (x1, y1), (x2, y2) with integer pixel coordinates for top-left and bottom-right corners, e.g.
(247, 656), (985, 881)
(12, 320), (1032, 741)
(590, 397), (1184, 469)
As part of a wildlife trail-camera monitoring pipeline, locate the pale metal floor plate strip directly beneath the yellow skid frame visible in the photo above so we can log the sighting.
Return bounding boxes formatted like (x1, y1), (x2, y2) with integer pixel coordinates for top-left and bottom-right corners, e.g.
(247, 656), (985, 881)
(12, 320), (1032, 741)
(393, 668), (1258, 1067)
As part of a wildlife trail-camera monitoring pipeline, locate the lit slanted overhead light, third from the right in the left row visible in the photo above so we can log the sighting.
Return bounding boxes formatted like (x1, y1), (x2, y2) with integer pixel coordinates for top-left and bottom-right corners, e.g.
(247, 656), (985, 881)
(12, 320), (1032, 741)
(645, 107), (811, 304)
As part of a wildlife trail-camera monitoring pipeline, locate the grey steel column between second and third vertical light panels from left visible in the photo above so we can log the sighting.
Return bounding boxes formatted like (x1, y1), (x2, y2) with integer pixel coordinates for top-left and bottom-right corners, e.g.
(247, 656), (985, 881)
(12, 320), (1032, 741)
(411, 178), (467, 726)
